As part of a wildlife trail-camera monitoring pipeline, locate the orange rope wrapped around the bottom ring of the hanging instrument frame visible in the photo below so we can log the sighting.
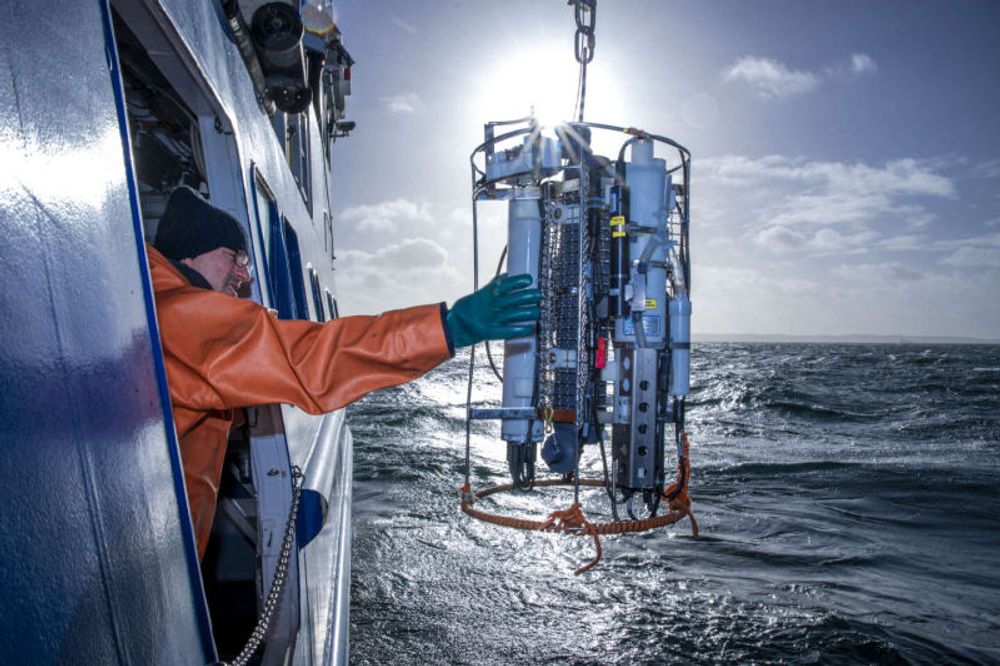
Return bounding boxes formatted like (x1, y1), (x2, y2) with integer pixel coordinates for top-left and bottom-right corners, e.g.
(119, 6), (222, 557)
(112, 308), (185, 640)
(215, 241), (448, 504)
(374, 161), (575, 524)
(461, 433), (699, 575)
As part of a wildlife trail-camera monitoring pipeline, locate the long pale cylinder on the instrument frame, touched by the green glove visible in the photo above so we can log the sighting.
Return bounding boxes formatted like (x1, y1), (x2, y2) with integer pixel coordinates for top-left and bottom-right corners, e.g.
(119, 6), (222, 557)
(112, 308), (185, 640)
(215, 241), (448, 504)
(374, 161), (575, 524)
(500, 199), (543, 442)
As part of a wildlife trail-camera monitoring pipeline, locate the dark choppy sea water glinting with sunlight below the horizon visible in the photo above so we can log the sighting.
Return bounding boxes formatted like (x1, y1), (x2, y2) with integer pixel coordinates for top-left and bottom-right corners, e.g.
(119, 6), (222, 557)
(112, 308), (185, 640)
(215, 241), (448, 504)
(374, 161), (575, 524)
(348, 344), (1000, 664)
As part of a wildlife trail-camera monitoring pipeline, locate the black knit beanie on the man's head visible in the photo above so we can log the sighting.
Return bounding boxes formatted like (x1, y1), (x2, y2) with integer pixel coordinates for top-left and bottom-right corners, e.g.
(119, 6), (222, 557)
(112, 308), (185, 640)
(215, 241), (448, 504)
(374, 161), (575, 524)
(153, 185), (247, 261)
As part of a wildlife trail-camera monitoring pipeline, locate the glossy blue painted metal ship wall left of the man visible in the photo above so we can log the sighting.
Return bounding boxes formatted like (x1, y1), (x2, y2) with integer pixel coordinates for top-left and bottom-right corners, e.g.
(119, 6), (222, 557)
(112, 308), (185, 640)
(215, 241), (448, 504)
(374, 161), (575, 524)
(0, 0), (214, 664)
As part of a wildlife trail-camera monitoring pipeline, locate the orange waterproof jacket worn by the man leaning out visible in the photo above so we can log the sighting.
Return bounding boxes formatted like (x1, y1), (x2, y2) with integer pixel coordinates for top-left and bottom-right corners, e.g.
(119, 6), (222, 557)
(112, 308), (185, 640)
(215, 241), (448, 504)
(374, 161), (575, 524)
(147, 246), (451, 557)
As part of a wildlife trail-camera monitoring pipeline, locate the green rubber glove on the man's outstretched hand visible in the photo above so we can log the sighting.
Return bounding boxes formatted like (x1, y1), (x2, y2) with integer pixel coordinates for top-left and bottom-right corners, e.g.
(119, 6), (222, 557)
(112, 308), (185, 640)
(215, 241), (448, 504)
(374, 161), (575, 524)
(446, 274), (542, 349)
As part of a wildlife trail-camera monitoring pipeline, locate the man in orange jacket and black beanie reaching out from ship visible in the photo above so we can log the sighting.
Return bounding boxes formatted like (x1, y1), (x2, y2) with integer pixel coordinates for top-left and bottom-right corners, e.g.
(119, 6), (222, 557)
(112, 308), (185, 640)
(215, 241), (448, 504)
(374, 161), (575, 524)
(148, 187), (541, 557)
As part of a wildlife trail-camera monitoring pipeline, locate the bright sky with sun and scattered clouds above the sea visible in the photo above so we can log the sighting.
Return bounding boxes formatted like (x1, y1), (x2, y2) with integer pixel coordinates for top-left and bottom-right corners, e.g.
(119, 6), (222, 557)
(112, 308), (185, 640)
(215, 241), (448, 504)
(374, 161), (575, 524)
(324, 0), (1000, 339)
